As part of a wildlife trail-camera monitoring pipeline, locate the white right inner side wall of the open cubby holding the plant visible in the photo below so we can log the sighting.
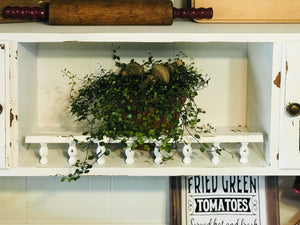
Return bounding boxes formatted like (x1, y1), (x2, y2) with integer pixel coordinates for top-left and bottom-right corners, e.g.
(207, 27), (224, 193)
(247, 43), (273, 162)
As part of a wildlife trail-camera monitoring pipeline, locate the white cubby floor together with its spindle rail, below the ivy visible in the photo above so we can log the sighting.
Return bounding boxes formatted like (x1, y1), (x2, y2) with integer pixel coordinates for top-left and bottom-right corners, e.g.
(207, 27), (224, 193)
(14, 127), (268, 176)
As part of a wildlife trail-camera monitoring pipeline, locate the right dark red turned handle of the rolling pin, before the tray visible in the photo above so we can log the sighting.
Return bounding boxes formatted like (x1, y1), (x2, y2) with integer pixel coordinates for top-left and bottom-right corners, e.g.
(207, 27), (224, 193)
(173, 8), (213, 19)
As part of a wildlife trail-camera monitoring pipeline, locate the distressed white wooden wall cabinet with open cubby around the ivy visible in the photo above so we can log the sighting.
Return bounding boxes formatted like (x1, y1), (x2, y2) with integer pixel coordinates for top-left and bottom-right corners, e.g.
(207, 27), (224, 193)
(0, 21), (300, 176)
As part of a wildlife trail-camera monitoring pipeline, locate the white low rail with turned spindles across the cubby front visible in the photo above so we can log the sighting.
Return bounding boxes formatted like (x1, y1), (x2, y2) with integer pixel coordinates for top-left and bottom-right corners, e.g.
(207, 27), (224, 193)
(25, 129), (263, 165)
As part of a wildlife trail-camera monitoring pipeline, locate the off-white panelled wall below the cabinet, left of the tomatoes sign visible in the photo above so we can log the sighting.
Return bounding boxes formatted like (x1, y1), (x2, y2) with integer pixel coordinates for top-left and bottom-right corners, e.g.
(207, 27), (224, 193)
(0, 177), (169, 225)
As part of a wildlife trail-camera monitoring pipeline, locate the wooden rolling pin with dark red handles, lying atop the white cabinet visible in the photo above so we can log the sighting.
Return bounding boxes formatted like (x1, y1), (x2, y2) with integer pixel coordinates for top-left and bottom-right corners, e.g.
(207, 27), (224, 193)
(3, 0), (213, 25)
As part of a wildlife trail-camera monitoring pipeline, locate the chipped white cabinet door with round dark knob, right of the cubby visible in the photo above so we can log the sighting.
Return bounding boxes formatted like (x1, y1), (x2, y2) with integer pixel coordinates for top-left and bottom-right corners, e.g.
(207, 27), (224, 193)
(279, 41), (300, 169)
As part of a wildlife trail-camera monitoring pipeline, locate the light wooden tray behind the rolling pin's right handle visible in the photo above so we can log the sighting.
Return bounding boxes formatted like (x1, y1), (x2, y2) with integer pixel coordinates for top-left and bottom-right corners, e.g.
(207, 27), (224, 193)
(190, 0), (300, 23)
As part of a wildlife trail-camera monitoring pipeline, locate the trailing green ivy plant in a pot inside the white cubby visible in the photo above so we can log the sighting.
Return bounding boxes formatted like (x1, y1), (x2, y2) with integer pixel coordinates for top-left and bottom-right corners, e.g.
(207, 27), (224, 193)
(62, 51), (220, 181)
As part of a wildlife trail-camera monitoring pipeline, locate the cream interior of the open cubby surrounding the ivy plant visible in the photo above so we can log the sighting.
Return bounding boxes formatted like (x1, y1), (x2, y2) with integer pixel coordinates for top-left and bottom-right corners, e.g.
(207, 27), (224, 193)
(12, 42), (273, 175)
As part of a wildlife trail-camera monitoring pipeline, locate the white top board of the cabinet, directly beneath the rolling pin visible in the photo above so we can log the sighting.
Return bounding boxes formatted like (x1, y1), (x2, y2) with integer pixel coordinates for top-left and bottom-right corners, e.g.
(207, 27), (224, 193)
(0, 21), (300, 42)
